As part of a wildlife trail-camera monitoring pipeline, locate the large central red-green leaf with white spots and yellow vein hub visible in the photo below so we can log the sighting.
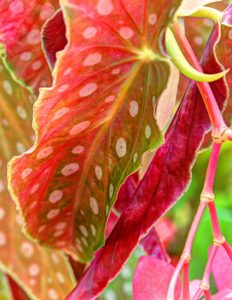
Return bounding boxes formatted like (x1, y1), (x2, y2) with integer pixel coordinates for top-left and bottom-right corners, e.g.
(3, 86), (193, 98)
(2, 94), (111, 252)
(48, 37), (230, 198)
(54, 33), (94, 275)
(11, 0), (180, 261)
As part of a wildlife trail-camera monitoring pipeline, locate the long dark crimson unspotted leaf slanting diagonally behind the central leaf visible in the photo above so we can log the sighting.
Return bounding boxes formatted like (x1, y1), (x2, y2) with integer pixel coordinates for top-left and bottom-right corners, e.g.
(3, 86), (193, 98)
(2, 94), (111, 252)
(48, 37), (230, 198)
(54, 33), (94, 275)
(68, 21), (227, 300)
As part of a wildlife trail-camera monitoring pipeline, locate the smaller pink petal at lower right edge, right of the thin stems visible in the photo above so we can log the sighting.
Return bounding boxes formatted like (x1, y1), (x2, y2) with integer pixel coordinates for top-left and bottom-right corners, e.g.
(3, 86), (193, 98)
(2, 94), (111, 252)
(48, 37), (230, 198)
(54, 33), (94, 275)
(212, 247), (232, 290)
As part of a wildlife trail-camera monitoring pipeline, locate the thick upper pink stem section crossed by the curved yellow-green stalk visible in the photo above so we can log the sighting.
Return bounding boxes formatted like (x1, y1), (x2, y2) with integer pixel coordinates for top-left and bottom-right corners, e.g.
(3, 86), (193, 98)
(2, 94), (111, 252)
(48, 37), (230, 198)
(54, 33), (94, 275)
(172, 22), (227, 132)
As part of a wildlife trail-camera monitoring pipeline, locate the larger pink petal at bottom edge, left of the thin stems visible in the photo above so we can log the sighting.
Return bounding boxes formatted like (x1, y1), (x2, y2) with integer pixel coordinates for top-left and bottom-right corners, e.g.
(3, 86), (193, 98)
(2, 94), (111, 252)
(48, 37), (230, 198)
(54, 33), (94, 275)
(133, 256), (181, 300)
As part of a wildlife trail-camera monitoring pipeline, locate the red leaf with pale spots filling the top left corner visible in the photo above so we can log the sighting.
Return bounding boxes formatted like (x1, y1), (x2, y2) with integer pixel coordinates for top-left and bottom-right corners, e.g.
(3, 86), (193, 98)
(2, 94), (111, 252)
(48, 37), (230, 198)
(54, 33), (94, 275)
(0, 0), (59, 94)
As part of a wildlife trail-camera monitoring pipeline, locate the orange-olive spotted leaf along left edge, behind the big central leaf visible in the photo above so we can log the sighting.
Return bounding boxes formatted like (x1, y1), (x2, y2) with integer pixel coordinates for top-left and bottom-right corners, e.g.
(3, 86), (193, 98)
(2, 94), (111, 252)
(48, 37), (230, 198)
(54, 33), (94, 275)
(0, 60), (73, 300)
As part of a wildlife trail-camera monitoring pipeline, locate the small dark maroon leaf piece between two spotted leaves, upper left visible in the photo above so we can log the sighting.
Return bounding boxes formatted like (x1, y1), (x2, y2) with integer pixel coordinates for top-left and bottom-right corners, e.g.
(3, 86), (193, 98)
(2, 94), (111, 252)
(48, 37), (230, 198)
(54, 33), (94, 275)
(42, 10), (67, 69)
